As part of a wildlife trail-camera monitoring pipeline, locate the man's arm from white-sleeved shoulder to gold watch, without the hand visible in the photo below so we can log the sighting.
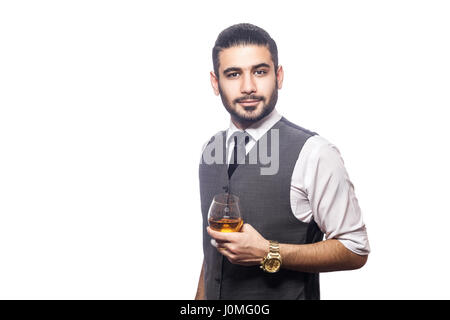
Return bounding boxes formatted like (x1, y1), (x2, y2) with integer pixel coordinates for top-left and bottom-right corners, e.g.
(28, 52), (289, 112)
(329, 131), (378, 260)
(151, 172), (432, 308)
(282, 136), (370, 272)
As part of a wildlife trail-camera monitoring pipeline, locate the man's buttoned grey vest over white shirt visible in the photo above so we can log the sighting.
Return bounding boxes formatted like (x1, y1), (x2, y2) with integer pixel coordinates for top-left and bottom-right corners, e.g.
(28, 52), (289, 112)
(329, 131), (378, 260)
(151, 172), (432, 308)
(199, 118), (323, 300)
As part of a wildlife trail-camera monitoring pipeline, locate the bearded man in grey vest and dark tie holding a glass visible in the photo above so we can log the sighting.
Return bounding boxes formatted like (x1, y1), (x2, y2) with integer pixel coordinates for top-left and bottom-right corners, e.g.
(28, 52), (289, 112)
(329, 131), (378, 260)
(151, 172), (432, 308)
(196, 23), (370, 299)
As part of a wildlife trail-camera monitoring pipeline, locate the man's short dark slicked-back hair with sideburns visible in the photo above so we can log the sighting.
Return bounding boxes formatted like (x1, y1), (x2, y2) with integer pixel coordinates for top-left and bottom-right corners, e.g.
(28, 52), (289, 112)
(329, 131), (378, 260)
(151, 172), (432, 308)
(212, 23), (278, 77)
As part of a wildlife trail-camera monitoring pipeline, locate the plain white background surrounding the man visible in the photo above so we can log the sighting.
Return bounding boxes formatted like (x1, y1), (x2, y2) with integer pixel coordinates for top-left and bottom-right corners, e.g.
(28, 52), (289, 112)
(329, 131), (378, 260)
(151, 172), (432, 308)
(0, 0), (450, 299)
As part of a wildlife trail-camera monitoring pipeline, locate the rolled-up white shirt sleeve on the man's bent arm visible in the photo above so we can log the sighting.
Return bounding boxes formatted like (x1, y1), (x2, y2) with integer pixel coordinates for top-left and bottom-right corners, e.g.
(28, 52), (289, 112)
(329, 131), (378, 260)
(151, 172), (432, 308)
(303, 137), (370, 255)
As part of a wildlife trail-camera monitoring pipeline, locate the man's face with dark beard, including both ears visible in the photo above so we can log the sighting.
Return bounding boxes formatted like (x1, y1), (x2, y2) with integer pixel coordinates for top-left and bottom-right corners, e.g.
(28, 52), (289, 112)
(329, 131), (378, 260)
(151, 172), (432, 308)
(211, 45), (283, 124)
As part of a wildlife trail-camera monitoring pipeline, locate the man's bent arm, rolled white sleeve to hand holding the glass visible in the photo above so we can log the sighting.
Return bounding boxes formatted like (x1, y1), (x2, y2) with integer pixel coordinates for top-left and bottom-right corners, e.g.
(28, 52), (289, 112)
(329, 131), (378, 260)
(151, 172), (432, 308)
(208, 138), (370, 272)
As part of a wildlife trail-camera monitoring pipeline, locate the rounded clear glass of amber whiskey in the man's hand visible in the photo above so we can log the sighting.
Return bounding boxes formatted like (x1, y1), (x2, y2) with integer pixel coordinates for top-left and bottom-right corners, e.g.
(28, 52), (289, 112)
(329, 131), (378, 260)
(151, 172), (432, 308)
(208, 193), (244, 232)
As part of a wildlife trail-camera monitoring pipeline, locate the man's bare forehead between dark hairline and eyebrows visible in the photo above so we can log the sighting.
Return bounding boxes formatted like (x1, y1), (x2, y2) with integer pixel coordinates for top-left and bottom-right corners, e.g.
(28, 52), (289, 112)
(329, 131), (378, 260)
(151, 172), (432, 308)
(219, 45), (273, 70)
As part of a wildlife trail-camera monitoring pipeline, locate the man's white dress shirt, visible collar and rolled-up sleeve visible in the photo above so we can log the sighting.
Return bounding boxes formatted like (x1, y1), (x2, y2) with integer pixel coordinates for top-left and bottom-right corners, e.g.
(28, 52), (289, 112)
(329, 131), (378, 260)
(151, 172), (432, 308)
(211, 109), (370, 255)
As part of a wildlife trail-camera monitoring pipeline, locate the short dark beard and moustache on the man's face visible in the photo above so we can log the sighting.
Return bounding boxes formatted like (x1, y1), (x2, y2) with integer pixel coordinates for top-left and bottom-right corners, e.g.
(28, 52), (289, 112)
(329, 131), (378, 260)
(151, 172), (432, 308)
(219, 81), (278, 124)
